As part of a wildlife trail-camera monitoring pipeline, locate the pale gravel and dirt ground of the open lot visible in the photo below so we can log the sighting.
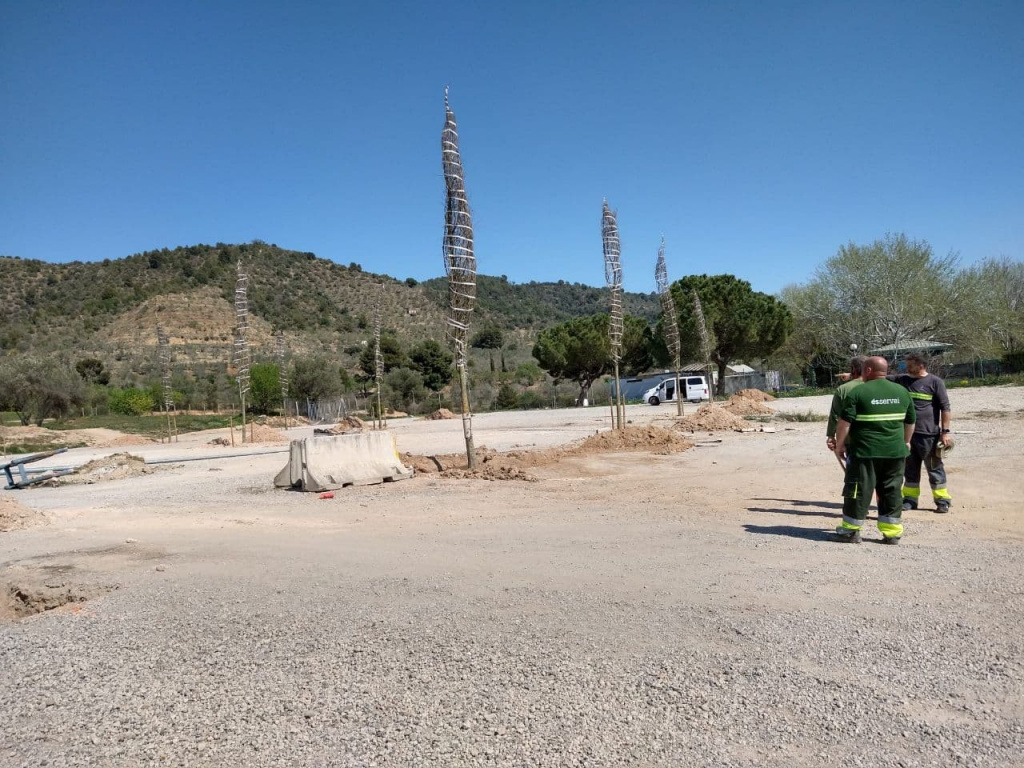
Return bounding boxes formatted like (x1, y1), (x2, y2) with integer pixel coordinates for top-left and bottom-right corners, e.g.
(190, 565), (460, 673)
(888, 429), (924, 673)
(0, 387), (1024, 766)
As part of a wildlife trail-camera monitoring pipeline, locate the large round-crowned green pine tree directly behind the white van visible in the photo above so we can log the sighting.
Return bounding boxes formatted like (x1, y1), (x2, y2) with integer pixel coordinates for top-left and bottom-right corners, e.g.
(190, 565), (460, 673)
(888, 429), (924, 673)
(670, 274), (793, 394)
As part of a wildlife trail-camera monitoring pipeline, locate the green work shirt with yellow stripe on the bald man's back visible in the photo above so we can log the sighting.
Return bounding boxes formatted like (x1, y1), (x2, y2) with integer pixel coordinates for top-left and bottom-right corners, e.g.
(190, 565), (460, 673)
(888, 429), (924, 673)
(840, 379), (918, 459)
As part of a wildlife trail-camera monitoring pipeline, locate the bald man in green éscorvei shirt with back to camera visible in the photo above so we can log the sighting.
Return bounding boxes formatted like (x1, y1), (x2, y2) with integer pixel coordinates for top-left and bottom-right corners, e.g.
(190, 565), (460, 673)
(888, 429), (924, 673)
(835, 356), (918, 544)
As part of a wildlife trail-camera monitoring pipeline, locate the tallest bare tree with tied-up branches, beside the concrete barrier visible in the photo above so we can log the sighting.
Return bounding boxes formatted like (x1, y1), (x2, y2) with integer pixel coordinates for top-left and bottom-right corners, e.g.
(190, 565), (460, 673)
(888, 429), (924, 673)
(441, 88), (476, 469)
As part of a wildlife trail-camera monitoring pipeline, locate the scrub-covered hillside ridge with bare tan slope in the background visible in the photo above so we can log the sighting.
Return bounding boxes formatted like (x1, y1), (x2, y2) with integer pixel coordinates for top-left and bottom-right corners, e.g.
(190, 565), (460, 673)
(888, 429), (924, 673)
(0, 242), (658, 359)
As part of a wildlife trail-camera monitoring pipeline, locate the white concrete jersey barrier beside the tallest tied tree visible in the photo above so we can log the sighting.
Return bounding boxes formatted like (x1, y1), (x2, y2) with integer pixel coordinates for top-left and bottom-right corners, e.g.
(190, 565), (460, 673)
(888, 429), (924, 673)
(273, 431), (413, 492)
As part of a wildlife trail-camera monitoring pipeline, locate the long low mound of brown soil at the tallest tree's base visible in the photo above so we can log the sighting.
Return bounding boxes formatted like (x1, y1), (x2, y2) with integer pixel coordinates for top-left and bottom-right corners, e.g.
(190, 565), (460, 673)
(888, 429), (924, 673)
(401, 426), (693, 482)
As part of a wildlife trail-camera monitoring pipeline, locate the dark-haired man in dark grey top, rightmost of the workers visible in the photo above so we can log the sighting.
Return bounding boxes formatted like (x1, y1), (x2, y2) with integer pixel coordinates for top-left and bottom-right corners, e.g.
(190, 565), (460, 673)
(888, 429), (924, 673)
(889, 352), (952, 513)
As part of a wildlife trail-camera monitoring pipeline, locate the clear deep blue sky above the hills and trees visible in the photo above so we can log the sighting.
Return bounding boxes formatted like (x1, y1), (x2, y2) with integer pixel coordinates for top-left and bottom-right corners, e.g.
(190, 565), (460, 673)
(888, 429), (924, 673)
(0, 0), (1024, 292)
